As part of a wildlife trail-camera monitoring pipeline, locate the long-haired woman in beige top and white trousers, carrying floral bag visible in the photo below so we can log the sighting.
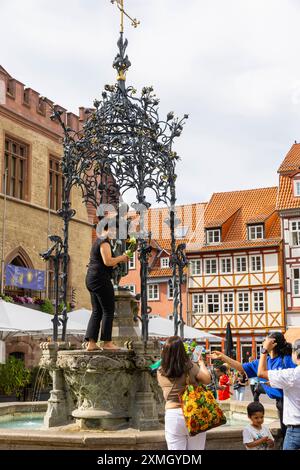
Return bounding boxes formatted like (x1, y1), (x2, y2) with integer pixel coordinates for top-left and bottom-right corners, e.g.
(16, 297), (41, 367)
(157, 336), (211, 450)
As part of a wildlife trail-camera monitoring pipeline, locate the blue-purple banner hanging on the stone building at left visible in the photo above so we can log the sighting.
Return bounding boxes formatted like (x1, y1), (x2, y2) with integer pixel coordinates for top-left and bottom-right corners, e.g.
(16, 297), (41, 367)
(5, 264), (45, 290)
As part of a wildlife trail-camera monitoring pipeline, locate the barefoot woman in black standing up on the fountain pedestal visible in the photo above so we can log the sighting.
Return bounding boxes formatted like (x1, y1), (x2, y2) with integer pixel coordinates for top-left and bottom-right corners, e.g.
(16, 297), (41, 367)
(85, 222), (129, 351)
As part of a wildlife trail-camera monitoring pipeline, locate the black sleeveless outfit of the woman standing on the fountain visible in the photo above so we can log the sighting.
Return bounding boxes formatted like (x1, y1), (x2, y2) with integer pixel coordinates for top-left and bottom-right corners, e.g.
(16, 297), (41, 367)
(85, 238), (115, 341)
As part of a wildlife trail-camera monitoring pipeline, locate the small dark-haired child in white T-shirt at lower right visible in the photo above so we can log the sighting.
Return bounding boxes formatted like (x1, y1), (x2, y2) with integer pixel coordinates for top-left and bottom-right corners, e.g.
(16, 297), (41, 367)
(243, 401), (274, 450)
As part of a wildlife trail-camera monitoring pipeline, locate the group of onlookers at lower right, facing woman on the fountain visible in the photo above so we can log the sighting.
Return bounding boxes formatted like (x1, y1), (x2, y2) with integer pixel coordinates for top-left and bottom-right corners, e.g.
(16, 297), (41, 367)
(157, 332), (300, 450)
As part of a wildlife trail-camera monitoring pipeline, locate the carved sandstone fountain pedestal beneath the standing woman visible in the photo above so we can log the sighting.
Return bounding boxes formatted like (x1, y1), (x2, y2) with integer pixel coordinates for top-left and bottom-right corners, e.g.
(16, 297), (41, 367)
(40, 290), (163, 430)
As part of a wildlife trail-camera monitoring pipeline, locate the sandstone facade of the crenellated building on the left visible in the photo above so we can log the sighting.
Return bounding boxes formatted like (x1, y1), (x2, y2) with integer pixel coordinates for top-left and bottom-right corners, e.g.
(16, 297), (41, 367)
(0, 67), (92, 308)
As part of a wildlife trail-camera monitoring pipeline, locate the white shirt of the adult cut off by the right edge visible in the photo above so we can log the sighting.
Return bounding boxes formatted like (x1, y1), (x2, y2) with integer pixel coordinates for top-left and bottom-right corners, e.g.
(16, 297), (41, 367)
(268, 366), (300, 426)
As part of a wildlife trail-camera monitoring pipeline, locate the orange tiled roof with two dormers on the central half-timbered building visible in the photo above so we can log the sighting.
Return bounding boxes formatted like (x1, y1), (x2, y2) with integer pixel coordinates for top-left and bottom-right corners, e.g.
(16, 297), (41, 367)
(198, 187), (280, 252)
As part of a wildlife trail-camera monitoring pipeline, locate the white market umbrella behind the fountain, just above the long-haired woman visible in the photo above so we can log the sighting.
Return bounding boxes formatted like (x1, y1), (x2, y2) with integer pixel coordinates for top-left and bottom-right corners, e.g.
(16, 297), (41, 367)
(148, 317), (221, 341)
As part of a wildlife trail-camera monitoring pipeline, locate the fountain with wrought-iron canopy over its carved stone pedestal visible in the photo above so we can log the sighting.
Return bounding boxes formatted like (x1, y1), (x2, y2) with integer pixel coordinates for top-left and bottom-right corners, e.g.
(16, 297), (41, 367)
(36, 1), (188, 431)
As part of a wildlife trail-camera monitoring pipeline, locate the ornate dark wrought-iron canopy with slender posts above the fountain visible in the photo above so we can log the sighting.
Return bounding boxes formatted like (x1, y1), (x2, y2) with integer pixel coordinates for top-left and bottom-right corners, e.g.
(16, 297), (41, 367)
(42, 2), (188, 341)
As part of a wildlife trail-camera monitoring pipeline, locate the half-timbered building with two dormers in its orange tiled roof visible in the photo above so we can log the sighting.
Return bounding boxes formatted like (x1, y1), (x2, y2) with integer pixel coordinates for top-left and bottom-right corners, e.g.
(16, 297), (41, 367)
(187, 187), (284, 360)
